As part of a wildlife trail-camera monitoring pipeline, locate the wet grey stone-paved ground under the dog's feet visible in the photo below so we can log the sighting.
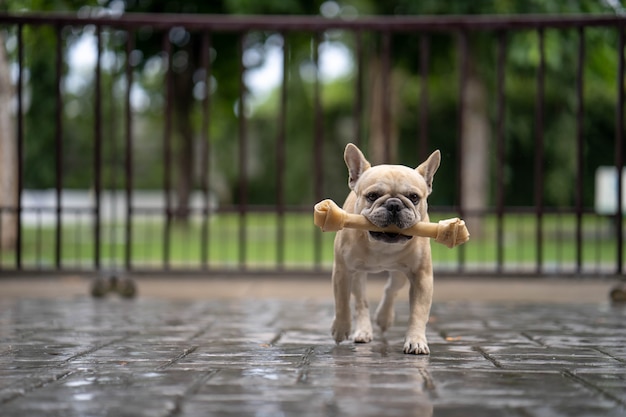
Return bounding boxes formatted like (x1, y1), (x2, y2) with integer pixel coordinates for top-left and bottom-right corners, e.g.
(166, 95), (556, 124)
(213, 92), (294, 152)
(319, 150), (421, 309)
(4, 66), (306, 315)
(0, 297), (626, 417)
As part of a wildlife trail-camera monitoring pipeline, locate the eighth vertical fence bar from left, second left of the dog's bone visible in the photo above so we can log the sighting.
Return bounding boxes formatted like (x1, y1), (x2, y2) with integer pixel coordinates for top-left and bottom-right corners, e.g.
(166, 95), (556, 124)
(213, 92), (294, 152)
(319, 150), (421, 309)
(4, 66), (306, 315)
(276, 33), (289, 269)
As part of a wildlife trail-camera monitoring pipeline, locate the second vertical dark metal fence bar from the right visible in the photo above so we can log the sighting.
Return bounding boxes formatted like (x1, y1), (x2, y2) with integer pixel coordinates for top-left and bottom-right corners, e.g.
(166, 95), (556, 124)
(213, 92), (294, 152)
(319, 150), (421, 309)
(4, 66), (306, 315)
(576, 27), (585, 274)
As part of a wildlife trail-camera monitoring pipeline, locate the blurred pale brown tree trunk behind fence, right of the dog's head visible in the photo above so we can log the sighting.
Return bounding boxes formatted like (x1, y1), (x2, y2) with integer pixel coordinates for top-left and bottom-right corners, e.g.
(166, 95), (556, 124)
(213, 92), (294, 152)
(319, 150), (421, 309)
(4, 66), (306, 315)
(461, 63), (490, 237)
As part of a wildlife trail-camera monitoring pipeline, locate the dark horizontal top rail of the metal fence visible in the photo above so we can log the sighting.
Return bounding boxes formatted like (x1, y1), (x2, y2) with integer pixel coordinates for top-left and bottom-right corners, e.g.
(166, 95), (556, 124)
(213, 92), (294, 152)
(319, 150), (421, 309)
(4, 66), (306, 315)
(0, 13), (626, 32)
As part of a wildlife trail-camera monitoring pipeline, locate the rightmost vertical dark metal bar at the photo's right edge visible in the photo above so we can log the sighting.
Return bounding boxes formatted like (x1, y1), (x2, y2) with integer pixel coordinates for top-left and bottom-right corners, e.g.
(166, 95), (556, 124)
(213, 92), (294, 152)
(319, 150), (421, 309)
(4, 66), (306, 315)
(615, 26), (624, 275)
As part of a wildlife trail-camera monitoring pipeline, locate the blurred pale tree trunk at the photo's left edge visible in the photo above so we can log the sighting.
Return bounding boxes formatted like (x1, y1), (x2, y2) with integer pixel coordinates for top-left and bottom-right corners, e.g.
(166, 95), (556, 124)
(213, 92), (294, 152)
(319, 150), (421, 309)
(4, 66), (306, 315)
(0, 33), (18, 249)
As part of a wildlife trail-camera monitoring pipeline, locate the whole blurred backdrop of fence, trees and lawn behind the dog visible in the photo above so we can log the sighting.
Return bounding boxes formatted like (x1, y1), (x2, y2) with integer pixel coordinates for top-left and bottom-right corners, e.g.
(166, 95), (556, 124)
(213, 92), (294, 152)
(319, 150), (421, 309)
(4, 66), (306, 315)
(0, 0), (624, 276)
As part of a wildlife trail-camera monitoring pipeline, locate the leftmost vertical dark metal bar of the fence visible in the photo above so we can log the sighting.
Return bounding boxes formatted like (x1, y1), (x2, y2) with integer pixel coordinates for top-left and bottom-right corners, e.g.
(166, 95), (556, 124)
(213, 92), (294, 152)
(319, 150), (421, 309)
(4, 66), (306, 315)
(15, 23), (24, 270)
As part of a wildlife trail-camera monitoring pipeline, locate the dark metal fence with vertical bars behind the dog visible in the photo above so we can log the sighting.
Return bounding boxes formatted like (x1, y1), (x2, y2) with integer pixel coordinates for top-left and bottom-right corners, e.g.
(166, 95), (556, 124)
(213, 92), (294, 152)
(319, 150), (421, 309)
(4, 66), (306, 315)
(0, 14), (626, 275)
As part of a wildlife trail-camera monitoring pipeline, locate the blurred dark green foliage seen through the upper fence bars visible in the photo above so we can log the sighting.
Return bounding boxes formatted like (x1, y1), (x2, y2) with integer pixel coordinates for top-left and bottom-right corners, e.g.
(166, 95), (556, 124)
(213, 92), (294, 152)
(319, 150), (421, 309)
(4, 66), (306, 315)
(0, 0), (623, 206)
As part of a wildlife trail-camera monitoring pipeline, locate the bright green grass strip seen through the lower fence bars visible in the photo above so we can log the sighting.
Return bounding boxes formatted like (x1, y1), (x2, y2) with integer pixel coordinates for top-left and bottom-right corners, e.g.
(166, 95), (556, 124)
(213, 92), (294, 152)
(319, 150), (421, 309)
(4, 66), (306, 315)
(0, 213), (617, 272)
